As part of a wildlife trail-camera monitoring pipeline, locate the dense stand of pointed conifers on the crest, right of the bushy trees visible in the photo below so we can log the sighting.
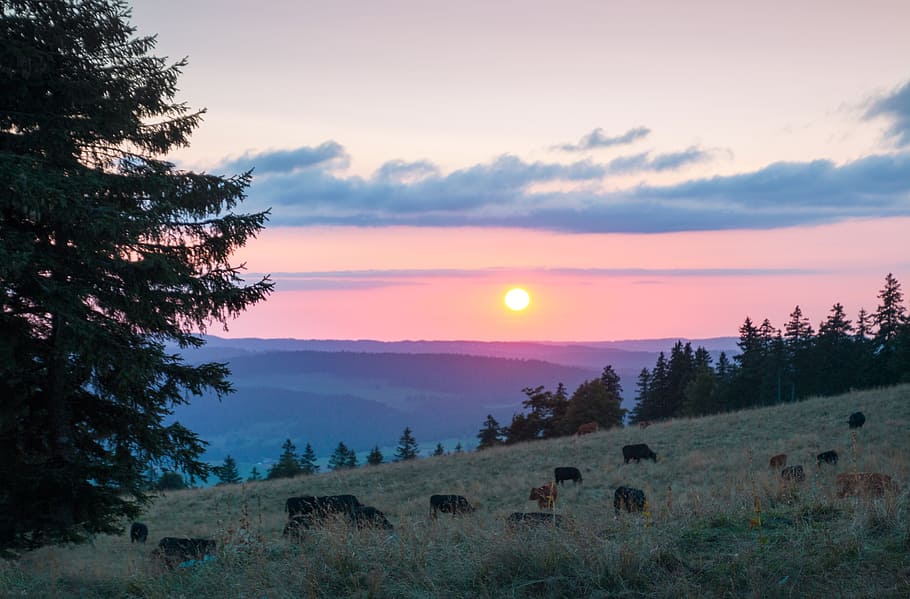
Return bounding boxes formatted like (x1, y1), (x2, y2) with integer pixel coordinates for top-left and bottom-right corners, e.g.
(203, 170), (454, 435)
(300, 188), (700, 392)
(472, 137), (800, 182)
(630, 273), (910, 423)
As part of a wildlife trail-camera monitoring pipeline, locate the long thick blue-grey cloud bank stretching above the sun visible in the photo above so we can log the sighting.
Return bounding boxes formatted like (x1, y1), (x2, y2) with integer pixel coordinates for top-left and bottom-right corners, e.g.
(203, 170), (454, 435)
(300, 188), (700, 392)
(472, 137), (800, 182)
(230, 142), (910, 233)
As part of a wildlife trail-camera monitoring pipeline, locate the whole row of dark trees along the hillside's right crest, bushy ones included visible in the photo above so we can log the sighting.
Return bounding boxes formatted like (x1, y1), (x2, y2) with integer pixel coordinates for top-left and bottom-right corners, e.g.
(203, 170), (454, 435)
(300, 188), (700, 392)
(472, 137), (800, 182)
(478, 273), (910, 448)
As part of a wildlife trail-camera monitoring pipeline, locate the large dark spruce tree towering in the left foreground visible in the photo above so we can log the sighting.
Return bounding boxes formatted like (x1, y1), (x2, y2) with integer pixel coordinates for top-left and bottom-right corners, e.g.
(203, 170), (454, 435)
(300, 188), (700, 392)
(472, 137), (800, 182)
(0, 0), (273, 552)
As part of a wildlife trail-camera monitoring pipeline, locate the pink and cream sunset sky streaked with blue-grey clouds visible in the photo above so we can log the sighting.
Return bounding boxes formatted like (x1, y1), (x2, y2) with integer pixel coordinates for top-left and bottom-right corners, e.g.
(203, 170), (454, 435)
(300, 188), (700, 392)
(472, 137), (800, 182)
(131, 0), (910, 341)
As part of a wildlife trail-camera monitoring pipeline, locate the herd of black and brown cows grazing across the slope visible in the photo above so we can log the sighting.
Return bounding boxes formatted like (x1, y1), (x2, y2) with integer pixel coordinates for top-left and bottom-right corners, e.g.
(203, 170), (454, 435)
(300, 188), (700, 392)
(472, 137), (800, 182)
(130, 412), (899, 567)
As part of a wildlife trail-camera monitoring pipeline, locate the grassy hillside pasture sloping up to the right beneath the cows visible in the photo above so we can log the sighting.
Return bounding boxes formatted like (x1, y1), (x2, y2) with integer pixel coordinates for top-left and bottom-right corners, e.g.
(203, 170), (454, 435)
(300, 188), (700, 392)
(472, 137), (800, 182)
(0, 386), (910, 597)
